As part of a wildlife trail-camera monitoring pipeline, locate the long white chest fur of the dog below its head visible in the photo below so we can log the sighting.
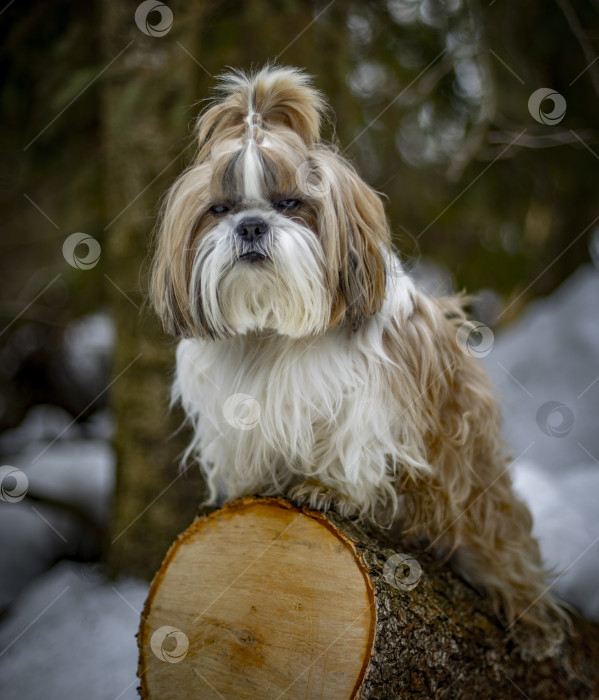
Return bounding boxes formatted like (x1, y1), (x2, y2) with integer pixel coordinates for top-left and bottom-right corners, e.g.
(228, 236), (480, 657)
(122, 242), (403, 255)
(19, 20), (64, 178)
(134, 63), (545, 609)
(173, 270), (421, 511)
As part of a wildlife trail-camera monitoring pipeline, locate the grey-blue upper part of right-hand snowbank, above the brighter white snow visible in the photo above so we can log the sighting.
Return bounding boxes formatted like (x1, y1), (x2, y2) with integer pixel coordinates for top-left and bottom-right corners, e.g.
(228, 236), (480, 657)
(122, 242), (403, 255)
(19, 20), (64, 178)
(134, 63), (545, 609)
(486, 265), (599, 474)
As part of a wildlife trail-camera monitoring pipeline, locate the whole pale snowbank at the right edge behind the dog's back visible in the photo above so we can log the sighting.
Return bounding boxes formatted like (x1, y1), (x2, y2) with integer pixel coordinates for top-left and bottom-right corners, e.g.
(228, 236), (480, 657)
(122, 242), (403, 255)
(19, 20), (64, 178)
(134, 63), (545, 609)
(485, 265), (599, 620)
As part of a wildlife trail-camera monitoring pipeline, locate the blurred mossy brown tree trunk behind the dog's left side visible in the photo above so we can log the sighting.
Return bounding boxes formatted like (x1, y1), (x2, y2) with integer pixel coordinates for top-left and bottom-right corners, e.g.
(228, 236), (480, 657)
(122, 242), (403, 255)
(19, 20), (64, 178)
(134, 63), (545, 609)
(102, 1), (211, 578)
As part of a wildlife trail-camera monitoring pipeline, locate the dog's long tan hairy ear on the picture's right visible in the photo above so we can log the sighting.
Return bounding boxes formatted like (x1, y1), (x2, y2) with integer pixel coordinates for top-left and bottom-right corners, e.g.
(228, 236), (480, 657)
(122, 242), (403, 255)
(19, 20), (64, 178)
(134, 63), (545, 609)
(305, 147), (390, 329)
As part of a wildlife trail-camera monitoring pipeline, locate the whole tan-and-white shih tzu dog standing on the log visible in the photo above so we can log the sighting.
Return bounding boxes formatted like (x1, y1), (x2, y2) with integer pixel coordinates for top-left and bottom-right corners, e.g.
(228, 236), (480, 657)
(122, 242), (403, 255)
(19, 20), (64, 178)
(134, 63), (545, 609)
(151, 66), (564, 629)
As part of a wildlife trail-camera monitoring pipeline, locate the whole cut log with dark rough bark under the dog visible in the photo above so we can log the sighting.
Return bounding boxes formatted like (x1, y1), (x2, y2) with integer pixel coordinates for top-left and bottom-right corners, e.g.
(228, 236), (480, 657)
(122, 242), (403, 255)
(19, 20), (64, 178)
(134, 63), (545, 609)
(138, 498), (599, 700)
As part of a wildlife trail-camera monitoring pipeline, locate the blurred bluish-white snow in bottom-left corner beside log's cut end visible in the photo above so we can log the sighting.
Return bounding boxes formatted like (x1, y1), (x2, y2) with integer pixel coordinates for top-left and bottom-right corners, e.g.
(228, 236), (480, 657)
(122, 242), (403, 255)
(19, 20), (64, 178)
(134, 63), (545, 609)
(0, 562), (148, 700)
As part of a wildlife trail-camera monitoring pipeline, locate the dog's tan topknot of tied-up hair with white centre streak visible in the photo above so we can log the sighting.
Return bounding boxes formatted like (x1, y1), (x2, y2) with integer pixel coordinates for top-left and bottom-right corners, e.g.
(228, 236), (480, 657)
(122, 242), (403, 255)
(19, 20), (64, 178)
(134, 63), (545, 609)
(196, 65), (327, 156)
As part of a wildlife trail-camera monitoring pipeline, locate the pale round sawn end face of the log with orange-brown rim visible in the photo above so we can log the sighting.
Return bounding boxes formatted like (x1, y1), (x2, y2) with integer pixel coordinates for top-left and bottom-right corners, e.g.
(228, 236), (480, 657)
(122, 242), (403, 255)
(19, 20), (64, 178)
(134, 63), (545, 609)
(139, 500), (376, 700)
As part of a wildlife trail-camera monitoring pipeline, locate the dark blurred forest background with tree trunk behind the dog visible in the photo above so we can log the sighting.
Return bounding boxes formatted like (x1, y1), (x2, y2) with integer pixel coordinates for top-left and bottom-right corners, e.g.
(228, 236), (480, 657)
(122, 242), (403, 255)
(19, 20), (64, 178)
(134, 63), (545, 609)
(0, 0), (599, 577)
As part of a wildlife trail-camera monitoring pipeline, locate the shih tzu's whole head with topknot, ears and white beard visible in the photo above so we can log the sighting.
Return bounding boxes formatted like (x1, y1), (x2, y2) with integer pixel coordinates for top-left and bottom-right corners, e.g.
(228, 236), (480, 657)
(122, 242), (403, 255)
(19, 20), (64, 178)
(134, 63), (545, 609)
(152, 68), (388, 338)
